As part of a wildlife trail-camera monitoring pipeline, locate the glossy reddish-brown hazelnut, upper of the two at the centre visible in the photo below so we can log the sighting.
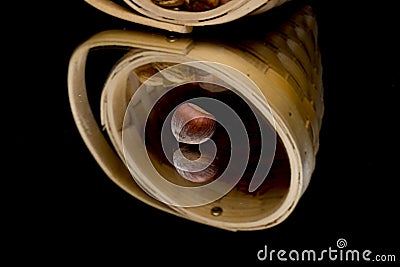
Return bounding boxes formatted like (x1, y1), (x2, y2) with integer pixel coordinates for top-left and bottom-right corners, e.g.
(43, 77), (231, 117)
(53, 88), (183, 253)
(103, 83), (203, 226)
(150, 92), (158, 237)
(171, 103), (217, 144)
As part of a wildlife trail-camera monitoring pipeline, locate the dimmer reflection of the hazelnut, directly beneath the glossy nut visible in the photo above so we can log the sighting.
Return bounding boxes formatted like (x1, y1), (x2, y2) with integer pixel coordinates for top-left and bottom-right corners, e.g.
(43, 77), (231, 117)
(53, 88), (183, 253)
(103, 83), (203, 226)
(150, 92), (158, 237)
(173, 148), (218, 183)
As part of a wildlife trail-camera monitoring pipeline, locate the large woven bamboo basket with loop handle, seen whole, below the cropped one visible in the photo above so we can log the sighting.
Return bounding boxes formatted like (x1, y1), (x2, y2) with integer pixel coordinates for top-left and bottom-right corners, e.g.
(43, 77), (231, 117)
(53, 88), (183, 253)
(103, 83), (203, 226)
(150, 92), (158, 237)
(68, 6), (324, 231)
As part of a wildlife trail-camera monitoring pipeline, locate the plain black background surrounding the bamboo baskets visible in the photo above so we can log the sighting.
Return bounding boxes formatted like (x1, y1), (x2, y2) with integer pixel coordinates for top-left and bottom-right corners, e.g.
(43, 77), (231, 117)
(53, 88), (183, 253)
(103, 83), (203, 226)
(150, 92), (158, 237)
(3, 0), (400, 266)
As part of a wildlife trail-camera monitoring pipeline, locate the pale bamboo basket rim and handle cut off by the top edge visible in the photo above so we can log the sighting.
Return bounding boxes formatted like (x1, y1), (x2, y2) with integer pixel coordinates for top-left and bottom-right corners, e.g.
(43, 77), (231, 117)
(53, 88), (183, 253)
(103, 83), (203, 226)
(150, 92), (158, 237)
(85, 0), (290, 33)
